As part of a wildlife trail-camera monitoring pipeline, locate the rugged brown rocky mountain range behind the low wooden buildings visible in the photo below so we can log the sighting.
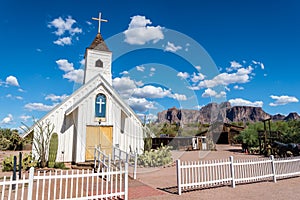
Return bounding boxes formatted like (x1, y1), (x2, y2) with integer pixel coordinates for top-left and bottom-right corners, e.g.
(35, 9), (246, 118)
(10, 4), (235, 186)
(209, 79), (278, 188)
(157, 102), (300, 124)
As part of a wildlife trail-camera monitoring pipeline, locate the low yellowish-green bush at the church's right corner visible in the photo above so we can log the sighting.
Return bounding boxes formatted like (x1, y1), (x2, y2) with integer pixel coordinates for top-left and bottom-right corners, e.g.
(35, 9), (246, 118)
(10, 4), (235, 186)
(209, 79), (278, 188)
(138, 146), (173, 167)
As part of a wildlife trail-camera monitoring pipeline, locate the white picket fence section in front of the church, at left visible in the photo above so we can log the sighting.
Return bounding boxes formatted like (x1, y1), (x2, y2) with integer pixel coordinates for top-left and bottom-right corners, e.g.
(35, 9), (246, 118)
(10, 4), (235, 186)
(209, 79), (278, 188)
(0, 164), (128, 200)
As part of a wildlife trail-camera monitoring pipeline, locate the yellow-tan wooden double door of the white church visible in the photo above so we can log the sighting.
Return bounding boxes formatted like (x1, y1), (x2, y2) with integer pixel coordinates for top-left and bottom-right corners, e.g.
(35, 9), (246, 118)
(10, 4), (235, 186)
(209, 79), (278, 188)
(85, 126), (113, 160)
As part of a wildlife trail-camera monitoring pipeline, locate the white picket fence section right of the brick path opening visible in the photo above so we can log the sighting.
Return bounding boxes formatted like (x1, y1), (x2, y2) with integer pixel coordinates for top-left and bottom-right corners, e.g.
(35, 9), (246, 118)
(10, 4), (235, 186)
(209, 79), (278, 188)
(176, 156), (300, 195)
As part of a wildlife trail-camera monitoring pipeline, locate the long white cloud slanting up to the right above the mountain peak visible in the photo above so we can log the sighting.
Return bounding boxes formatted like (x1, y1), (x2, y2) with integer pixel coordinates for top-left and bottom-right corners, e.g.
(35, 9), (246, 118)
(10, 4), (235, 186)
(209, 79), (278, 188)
(194, 66), (253, 89)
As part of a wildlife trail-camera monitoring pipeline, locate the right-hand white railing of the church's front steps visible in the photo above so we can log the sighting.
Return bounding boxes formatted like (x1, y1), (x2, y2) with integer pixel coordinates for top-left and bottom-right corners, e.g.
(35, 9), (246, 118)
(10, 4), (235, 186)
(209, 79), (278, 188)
(112, 146), (138, 179)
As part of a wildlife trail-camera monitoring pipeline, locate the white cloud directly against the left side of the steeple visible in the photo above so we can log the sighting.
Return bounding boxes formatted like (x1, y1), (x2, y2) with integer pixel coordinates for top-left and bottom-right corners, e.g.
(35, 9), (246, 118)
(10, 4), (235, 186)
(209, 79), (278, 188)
(56, 59), (84, 83)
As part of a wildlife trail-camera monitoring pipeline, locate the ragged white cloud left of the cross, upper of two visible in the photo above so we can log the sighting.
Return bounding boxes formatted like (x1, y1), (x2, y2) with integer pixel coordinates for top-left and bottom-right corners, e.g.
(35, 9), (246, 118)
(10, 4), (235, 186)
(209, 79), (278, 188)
(48, 16), (82, 36)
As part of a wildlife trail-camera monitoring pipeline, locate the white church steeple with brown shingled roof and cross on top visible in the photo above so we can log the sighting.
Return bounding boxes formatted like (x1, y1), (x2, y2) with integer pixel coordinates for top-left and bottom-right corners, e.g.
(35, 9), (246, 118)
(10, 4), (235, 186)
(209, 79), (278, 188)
(83, 13), (112, 85)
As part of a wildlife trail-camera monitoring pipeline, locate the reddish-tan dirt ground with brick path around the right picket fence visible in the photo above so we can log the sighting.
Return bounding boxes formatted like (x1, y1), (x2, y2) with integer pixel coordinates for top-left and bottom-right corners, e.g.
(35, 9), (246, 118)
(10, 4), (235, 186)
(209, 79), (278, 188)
(129, 145), (300, 200)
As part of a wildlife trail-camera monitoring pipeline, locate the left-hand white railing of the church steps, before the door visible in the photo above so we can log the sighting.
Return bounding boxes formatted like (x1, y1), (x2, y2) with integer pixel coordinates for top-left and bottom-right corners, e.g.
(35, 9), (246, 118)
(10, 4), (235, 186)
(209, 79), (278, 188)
(94, 146), (111, 180)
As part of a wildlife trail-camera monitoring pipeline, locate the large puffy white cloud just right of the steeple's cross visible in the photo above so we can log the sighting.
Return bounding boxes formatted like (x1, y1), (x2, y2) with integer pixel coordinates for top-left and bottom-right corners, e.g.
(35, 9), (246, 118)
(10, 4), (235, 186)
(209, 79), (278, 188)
(124, 15), (164, 45)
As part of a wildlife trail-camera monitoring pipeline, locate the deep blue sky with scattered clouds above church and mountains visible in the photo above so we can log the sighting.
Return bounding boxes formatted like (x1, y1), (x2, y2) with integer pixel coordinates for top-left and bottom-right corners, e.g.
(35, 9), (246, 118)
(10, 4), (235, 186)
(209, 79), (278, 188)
(0, 0), (300, 128)
